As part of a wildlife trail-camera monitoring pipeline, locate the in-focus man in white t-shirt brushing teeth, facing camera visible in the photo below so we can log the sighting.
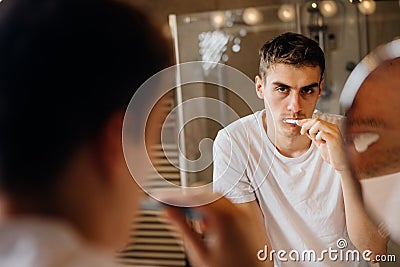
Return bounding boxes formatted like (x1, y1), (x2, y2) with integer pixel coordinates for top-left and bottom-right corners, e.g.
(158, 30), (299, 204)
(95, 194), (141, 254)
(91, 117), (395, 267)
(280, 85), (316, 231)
(214, 33), (386, 266)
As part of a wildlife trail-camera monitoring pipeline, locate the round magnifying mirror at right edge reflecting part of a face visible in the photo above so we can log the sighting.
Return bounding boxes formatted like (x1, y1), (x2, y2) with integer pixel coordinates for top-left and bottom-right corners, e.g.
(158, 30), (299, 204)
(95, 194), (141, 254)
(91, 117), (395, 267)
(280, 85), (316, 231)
(341, 40), (400, 254)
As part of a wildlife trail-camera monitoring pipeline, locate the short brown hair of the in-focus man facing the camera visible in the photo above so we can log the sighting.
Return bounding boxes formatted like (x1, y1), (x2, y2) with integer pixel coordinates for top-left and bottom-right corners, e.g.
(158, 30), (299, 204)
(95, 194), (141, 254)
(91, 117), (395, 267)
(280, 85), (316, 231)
(259, 32), (325, 79)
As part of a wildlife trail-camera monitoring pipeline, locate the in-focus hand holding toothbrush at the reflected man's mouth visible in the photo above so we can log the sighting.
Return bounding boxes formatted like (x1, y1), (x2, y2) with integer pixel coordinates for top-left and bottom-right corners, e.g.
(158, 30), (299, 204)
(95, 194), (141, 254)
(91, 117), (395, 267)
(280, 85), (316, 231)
(297, 119), (348, 172)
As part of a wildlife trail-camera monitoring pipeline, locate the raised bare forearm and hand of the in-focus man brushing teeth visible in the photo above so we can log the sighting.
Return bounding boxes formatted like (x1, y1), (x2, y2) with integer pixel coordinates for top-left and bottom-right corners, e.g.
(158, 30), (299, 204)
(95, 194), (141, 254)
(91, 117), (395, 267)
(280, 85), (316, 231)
(298, 119), (387, 259)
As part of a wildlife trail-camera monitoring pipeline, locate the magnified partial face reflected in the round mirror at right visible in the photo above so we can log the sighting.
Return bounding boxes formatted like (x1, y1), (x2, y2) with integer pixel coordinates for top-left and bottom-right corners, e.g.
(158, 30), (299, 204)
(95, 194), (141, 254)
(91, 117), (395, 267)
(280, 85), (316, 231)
(347, 58), (400, 179)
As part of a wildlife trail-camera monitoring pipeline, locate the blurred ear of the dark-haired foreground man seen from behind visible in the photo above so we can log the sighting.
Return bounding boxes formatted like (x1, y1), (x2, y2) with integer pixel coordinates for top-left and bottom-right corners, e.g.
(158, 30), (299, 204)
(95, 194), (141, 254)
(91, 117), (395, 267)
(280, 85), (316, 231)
(93, 111), (126, 182)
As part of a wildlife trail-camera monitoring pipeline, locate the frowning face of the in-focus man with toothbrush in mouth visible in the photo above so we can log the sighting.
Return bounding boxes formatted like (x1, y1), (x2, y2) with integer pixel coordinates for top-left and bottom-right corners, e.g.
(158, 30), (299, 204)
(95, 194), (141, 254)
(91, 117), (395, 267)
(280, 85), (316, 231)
(256, 63), (322, 137)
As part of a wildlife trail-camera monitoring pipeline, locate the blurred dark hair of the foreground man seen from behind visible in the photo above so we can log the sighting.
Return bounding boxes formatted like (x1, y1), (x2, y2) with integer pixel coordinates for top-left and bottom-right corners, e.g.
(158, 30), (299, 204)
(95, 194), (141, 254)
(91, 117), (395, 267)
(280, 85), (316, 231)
(0, 0), (171, 196)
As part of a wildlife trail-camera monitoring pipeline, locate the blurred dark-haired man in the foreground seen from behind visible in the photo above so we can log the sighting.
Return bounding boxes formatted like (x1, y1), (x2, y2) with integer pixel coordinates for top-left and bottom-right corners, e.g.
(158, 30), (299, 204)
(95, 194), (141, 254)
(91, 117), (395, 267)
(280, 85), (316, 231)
(0, 0), (268, 267)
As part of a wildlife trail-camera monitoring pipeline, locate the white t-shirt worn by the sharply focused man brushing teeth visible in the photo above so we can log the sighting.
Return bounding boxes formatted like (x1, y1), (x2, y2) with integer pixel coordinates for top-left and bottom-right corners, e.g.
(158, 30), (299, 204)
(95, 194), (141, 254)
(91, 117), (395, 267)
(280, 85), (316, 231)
(213, 111), (368, 266)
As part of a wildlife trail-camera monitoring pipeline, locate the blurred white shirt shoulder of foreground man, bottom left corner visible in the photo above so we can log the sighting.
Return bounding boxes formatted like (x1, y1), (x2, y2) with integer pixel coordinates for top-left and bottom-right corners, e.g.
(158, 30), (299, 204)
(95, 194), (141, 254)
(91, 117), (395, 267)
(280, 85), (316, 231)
(0, 218), (117, 267)
